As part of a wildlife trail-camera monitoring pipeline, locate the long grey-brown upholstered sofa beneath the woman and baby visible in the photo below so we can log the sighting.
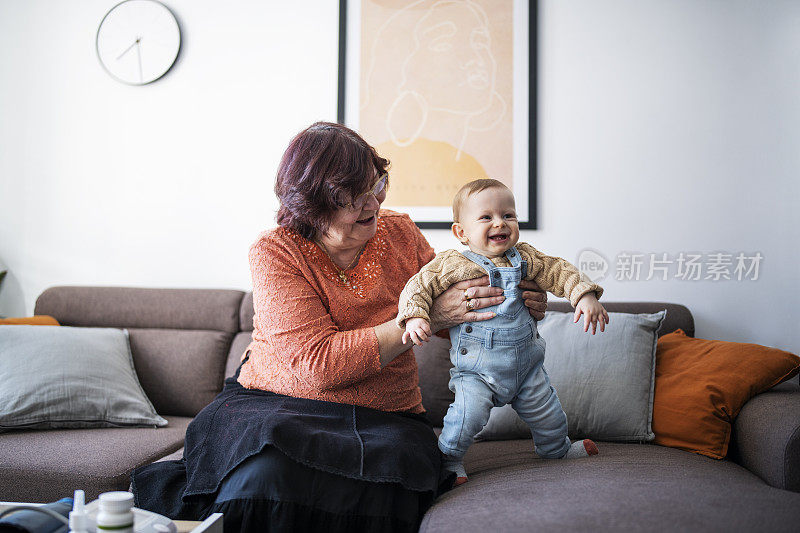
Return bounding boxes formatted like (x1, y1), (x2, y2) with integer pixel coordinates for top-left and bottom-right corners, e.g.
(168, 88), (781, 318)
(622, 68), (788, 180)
(0, 287), (800, 533)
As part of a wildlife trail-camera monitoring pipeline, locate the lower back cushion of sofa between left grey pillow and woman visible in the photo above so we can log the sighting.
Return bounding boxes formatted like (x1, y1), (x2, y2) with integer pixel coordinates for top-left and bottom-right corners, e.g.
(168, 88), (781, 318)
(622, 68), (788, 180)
(130, 329), (233, 416)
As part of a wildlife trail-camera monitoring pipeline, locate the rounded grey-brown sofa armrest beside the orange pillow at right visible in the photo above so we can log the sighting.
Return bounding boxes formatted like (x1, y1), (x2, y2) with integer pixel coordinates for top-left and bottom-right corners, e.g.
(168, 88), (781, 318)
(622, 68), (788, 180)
(731, 380), (800, 492)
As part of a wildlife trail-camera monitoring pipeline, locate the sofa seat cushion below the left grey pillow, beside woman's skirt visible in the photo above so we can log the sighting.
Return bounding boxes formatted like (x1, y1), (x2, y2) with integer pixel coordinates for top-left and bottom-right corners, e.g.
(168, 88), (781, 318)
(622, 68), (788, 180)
(0, 416), (192, 502)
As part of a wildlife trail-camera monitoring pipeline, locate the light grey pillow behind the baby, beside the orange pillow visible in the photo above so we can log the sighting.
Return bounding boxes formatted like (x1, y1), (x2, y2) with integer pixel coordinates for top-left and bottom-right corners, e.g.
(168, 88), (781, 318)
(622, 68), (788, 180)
(476, 310), (667, 442)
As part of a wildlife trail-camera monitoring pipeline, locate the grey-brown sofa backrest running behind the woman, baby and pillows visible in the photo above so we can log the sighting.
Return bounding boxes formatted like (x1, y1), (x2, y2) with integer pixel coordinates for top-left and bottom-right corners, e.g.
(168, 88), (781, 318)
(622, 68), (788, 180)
(35, 287), (694, 423)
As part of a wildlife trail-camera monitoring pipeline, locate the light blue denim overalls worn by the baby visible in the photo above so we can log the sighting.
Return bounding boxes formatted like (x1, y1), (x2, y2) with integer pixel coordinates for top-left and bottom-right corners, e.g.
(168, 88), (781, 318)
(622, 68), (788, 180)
(439, 247), (570, 461)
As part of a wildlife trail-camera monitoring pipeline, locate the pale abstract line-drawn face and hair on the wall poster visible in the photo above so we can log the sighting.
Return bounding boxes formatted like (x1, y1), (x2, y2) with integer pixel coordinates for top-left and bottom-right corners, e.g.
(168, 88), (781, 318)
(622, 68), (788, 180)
(360, 0), (508, 160)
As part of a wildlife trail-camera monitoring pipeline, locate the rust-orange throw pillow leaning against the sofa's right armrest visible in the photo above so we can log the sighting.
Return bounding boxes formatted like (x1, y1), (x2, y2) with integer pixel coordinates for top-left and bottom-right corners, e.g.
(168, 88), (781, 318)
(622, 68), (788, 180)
(653, 329), (800, 459)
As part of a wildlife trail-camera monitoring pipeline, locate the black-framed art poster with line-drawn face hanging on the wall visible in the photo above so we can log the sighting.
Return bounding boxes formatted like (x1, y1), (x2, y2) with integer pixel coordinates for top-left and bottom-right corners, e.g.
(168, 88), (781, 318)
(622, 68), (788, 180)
(338, 0), (536, 229)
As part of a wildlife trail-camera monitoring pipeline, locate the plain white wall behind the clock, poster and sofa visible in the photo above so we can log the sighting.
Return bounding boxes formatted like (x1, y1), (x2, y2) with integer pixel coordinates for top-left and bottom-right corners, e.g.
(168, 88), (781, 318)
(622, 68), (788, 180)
(0, 0), (800, 353)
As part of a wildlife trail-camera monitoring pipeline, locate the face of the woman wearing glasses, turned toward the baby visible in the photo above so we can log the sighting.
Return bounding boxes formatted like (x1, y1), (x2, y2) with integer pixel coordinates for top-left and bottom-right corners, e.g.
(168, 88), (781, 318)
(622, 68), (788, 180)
(320, 175), (386, 251)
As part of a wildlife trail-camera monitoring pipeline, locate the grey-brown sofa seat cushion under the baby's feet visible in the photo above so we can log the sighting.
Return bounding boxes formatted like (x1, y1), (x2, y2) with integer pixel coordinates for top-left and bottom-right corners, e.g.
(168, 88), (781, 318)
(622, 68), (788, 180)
(420, 440), (800, 533)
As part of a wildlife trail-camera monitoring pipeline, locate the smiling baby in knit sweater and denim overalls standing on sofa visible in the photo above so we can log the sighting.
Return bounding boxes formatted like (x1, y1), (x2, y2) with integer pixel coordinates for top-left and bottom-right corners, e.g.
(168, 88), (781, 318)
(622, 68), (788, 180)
(397, 179), (608, 485)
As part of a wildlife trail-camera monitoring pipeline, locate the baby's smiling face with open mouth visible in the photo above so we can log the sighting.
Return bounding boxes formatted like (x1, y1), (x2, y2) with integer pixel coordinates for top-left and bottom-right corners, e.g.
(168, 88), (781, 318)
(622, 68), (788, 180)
(453, 187), (519, 257)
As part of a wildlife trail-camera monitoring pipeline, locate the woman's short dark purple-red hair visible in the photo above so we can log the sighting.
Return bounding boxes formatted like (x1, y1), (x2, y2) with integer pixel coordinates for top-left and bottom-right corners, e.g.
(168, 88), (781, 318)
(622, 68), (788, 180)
(275, 122), (389, 239)
